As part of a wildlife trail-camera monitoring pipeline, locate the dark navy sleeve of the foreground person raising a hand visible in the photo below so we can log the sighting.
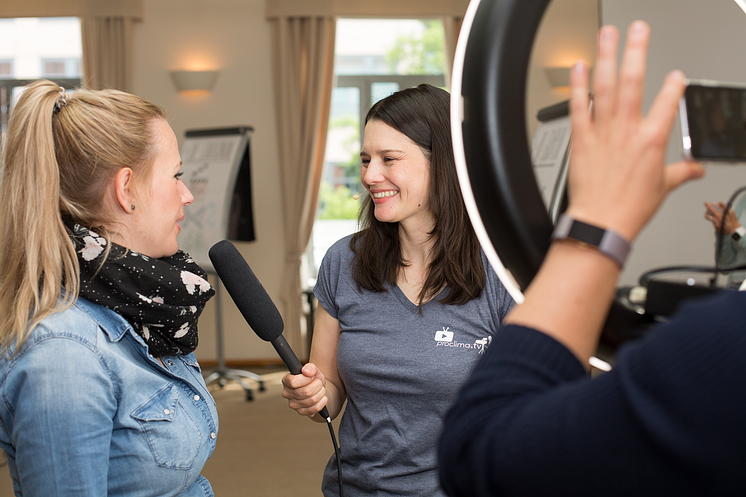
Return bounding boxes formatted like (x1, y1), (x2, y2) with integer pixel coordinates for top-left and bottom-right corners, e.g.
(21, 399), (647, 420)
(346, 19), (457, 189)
(439, 292), (746, 497)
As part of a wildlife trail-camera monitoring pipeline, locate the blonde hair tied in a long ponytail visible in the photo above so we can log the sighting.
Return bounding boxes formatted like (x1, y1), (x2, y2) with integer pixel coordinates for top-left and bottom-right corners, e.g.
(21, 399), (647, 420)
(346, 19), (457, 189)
(0, 80), (165, 350)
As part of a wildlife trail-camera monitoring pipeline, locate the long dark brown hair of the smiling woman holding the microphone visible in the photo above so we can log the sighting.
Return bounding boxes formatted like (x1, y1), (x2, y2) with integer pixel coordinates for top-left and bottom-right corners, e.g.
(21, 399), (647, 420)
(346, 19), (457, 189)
(350, 84), (486, 305)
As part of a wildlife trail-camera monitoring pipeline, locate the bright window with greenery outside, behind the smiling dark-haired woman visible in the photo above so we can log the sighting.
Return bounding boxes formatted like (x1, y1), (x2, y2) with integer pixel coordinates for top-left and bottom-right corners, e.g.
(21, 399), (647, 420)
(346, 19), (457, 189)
(306, 19), (445, 277)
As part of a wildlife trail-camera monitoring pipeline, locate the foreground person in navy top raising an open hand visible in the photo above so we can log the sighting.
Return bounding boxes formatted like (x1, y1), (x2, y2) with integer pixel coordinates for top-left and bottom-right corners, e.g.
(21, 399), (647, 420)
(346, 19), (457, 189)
(439, 21), (746, 497)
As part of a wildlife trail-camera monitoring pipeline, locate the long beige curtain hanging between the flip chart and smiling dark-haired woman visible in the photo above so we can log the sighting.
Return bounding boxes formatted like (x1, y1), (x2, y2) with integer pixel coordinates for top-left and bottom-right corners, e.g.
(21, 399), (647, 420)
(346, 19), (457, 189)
(270, 16), (336, 356)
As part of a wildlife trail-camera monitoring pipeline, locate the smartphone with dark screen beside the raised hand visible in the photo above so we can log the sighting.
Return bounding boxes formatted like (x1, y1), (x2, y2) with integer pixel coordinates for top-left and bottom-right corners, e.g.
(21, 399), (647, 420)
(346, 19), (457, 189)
(679, 80), (746, 162)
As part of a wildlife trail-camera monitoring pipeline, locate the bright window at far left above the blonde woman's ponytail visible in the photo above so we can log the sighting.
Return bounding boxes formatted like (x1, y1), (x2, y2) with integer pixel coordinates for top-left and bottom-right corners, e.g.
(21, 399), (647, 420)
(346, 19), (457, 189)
(0, 17), (83, 133)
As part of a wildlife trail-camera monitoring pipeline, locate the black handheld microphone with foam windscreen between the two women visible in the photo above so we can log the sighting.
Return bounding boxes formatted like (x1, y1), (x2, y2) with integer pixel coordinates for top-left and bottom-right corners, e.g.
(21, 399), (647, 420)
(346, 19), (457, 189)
(208, 240), (329, 419)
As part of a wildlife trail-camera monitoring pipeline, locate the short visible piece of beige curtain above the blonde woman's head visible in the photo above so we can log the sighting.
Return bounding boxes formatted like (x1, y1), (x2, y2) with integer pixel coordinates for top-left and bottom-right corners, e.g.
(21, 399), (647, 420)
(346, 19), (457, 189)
(80, 16), (134, 91)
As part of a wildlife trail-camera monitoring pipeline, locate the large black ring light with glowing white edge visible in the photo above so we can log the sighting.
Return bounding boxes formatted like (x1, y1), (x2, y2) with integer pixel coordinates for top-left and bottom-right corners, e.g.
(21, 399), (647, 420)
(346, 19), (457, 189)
(451, 0), (647, 347)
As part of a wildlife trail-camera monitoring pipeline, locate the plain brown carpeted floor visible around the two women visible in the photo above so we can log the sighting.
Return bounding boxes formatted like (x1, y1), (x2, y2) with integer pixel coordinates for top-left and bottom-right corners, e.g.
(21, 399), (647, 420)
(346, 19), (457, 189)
(0, 368), (338, 497)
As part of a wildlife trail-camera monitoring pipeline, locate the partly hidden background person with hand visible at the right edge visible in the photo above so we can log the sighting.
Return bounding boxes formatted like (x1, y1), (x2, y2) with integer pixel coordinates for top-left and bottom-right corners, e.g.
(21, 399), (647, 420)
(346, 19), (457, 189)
(705, 195), (746, 284)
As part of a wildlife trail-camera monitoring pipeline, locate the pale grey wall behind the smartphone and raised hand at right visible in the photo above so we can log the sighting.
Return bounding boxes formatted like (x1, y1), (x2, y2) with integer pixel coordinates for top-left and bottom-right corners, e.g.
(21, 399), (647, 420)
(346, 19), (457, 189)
(601, 0), (746, 284)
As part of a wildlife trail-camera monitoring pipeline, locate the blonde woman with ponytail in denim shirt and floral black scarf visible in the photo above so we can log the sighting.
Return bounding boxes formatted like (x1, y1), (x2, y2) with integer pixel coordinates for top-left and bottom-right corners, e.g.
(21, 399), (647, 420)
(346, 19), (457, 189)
(0, 80), (218, 497)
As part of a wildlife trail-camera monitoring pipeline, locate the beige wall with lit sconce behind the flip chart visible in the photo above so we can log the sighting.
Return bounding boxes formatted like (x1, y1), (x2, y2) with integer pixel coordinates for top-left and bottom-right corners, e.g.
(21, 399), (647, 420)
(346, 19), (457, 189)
(132, 0), (284, 361)
